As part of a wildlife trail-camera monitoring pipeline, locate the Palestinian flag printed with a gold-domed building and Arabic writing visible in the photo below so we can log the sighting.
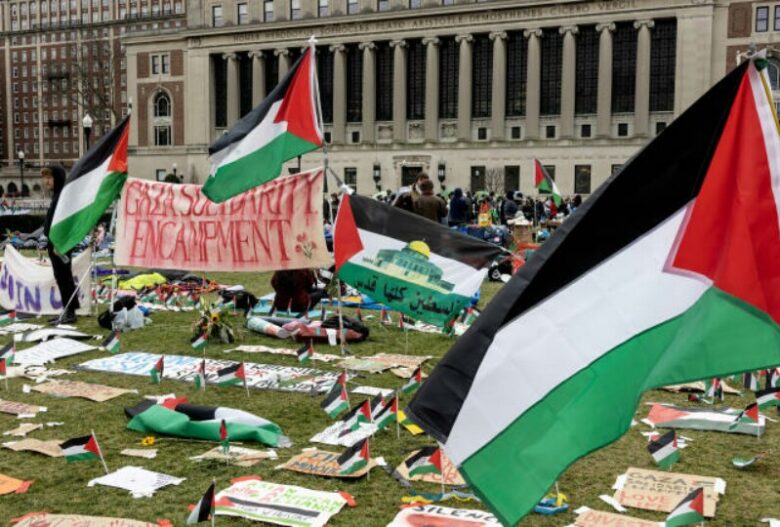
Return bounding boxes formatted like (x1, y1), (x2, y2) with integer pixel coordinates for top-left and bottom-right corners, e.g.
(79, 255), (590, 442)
(333, 194), (501, 326)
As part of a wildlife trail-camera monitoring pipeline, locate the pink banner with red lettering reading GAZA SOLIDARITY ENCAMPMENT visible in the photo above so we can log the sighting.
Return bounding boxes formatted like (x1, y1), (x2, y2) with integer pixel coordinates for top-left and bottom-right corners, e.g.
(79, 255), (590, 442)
(114, 169), (331, 272)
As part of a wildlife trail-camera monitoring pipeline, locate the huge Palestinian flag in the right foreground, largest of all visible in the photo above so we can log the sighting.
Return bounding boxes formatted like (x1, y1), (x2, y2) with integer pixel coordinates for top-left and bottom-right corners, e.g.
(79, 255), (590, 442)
(409, 55), (780, 525)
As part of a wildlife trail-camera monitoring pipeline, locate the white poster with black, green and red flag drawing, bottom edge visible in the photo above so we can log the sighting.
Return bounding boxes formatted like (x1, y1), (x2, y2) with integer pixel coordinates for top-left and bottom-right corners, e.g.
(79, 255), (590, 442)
(216, 480), (347, 527)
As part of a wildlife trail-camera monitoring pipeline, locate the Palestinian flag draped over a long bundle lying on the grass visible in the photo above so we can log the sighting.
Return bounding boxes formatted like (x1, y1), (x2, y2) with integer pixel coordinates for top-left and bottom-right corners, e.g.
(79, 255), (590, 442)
(125, 400), (289, 447)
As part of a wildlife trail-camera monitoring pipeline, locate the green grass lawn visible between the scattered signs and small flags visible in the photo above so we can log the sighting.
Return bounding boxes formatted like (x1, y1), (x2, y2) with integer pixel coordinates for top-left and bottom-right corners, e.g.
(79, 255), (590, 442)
(0, 274), (780, 527)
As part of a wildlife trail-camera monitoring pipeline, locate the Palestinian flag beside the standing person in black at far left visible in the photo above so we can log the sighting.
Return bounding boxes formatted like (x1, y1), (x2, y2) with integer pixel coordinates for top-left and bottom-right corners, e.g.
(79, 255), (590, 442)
(49, 114), (130, 254)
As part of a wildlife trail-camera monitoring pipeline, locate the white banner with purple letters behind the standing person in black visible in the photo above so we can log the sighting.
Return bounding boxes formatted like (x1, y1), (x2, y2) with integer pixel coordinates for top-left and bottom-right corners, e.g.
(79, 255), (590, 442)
(0, 245), (92, 316)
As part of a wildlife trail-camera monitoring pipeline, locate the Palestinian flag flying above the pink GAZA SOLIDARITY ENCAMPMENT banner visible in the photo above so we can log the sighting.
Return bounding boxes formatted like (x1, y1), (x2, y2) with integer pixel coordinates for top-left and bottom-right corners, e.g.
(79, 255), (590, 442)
(203, 47), (322, 203)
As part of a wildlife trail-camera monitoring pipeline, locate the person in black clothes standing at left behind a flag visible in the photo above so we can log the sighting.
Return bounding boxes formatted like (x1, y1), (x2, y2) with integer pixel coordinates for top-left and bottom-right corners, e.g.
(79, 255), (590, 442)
(41, 165), (80, 324)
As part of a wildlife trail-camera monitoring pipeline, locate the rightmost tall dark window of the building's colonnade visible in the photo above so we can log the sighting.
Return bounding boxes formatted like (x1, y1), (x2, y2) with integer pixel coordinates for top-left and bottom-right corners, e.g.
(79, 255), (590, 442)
(650, 19), (677, 112)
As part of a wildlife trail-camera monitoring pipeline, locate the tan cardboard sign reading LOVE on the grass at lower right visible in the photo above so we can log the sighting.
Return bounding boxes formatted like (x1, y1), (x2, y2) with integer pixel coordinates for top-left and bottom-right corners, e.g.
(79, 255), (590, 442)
(613, 467), (726, 518)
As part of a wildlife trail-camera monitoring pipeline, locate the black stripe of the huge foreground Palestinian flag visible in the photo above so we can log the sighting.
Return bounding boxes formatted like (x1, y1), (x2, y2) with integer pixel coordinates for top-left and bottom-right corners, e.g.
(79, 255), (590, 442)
(408, 61), (750, 443)
